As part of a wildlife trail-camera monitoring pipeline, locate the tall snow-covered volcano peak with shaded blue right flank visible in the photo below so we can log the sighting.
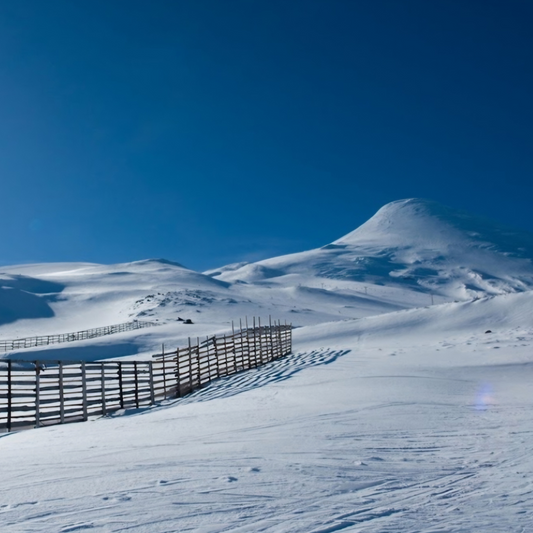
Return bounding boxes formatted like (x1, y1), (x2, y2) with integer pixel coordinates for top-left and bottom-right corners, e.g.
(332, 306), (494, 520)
(206, 199), (533, 299)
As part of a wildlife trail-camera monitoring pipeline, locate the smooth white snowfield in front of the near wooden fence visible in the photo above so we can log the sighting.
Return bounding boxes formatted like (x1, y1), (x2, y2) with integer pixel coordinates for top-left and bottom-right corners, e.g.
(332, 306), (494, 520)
(0, 292), (533, 533)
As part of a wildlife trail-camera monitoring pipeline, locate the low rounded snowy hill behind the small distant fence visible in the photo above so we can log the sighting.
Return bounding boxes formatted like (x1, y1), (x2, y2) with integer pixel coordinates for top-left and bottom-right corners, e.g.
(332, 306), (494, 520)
(0, 259), (230, 337)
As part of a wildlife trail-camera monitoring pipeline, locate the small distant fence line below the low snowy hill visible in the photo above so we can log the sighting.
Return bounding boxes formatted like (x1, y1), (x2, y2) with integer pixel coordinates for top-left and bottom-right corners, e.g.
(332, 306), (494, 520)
(0, 320), (159, 352)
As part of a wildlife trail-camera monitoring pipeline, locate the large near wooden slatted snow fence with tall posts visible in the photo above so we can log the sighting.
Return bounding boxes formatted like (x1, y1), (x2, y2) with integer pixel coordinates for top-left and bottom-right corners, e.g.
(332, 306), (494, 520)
(0, 319), (292, 431)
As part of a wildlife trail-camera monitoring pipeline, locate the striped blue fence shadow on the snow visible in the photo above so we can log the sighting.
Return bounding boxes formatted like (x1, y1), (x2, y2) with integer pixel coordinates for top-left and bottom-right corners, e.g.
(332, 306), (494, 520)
(173, 349), (350, 405)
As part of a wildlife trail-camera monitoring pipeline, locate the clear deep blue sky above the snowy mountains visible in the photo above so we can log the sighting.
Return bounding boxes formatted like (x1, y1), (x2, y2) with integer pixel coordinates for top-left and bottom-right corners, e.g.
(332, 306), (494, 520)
(0, 0), (533, 270)
